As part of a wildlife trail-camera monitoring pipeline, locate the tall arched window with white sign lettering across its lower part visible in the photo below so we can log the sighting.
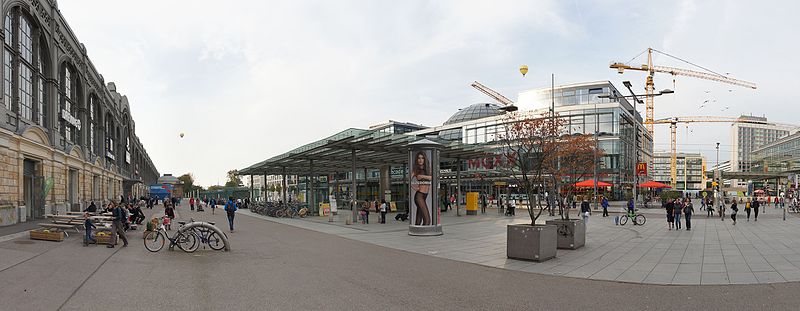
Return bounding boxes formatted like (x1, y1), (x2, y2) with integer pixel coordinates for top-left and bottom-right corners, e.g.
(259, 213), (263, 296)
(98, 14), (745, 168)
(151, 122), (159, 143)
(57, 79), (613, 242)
(59, 63), (81, 143)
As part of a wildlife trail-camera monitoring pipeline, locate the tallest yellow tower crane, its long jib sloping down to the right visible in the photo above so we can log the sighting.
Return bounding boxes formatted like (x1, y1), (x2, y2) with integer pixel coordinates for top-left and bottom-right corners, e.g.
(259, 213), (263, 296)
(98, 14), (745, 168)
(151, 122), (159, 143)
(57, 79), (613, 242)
(609, 48), (756, 136)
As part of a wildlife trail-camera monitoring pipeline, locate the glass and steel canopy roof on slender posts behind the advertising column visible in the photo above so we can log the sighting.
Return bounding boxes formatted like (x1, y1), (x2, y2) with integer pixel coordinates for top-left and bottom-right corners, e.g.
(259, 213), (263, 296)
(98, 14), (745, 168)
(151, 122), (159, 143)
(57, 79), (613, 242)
(239, 128), (492, 175)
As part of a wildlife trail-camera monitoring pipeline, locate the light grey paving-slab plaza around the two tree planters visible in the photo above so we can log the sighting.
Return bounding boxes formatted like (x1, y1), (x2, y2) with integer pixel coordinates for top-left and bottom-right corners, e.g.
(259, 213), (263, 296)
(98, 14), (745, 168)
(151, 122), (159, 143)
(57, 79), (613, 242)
(250, 207), (800, 285)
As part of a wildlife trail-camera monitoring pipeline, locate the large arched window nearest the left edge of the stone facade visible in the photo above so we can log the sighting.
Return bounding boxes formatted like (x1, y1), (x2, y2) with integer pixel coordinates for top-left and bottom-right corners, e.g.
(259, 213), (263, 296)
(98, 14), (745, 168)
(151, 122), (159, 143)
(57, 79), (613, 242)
(3, 7), (47, 127)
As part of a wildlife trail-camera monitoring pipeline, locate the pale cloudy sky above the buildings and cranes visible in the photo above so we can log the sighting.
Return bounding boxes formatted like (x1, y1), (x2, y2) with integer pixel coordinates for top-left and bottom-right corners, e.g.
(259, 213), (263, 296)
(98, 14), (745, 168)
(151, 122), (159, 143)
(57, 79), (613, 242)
(59, 0), (800, 186)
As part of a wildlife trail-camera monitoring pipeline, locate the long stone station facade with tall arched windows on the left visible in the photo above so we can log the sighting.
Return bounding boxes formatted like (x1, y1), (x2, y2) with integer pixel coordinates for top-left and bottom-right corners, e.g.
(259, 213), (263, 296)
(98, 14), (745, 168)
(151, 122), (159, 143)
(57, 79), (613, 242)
(0, 0), (159, 226)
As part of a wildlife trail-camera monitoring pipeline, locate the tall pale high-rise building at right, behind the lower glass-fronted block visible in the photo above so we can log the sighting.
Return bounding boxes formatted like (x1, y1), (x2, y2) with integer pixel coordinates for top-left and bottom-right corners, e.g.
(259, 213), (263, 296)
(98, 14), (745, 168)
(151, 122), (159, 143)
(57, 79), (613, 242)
(731, 115), (798, 187)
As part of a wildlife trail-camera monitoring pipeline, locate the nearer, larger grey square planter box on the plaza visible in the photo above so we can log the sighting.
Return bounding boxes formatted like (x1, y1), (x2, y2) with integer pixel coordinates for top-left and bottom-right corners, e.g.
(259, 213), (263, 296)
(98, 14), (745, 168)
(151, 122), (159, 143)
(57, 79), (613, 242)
(506, 224), (556, 261)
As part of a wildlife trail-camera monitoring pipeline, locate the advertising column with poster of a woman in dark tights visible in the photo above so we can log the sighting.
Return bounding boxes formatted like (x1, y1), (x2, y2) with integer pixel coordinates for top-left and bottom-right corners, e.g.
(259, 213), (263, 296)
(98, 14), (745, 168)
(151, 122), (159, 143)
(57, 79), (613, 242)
(408, 139), (442, 236)
